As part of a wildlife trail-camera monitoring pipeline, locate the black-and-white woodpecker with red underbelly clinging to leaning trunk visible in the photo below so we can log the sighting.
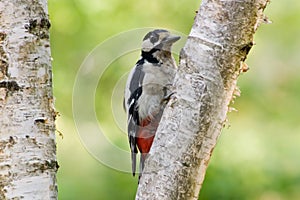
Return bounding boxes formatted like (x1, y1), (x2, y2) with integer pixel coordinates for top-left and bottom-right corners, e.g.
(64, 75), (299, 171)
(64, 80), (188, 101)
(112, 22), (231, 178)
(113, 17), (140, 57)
(123, 29), (180, 179)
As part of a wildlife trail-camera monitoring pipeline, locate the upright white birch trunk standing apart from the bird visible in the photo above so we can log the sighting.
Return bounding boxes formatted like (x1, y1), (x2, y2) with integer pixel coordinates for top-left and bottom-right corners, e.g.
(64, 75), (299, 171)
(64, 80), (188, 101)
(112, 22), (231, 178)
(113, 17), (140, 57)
(0, 0), (58, 200)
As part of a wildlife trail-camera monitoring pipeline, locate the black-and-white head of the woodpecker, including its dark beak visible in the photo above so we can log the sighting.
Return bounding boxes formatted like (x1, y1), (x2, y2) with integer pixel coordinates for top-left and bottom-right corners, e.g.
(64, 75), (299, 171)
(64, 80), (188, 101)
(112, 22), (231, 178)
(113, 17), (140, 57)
(142, 29), (180, 52)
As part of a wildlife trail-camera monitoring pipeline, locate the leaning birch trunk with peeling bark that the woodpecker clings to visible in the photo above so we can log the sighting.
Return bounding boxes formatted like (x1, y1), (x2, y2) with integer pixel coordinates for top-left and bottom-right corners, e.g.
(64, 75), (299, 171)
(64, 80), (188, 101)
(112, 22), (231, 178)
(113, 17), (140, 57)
(136, 0), (268, 200)
